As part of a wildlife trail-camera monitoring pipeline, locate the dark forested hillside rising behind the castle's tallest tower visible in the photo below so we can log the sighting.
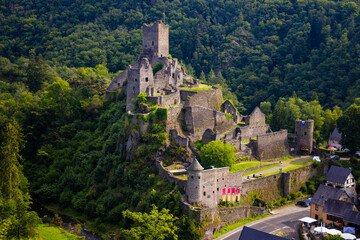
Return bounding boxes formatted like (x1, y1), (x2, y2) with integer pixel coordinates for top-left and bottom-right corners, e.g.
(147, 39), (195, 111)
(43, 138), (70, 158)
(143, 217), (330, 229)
(0, 0), (360, 111)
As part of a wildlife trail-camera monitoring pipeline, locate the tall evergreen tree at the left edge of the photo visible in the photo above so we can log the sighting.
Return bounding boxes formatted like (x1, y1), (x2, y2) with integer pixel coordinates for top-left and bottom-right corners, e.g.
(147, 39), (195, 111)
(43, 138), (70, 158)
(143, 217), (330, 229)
(0, 120), (40, 239)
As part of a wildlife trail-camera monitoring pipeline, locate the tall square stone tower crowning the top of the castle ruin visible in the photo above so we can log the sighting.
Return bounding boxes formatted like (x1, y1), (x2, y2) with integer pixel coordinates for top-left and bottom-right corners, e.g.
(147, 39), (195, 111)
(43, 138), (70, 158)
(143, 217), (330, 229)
(143, 20), (169, 57)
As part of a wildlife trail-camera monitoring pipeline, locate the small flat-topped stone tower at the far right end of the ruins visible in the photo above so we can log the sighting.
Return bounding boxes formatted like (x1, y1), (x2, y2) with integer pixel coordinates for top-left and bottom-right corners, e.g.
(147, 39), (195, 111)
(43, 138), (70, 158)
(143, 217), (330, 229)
(295, 120), (314, 154)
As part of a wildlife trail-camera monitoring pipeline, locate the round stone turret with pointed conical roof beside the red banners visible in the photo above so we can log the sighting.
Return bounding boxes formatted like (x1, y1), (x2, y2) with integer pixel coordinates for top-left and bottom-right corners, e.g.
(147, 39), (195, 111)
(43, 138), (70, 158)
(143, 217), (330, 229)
(186, 158), (204, 203)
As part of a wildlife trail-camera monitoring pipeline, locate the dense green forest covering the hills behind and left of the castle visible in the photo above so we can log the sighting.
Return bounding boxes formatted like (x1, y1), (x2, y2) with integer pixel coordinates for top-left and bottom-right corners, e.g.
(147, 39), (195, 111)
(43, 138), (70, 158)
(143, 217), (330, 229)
(0, 0), (360, 239)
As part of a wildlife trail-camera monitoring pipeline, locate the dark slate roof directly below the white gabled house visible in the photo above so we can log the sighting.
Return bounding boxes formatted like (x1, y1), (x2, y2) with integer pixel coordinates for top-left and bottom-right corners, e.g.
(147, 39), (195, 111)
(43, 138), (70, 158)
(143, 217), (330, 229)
(311, 184), (347, 206)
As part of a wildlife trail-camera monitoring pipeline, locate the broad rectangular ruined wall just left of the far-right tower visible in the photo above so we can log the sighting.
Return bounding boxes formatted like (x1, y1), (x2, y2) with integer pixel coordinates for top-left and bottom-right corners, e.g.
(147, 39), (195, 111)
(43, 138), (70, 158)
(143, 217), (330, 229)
(253, 130), (289, 159)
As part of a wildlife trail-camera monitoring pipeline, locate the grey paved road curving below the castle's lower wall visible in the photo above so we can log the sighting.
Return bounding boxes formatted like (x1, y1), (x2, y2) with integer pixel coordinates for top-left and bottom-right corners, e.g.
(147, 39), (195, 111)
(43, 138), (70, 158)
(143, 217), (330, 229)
(216, 206), (310, 240)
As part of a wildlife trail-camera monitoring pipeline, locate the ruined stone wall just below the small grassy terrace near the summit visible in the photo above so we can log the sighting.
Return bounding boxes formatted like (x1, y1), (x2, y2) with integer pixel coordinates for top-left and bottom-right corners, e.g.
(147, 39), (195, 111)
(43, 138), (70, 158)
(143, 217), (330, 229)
(180, 88), (223, 111)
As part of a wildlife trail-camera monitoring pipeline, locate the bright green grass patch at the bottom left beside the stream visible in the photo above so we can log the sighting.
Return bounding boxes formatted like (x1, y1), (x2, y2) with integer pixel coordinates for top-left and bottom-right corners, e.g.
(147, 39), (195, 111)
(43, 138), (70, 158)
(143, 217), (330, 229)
(36, 224), (85, 240)
